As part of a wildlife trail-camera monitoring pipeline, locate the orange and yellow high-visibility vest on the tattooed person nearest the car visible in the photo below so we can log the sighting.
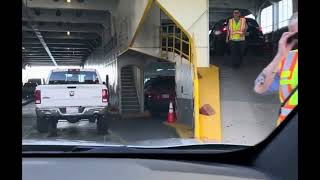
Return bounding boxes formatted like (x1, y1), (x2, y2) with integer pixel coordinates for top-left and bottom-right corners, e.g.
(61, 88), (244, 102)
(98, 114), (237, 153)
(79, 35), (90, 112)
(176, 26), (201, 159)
(277, 50), (298, 126)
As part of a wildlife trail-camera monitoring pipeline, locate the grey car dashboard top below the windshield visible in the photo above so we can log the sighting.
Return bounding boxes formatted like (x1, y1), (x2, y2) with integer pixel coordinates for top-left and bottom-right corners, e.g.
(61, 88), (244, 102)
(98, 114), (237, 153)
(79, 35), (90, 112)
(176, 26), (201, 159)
(22, 157), (271, 180)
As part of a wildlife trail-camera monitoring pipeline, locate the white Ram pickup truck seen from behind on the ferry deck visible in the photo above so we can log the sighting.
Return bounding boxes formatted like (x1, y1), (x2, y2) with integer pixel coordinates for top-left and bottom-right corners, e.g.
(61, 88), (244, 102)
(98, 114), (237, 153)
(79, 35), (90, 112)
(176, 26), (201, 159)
(35, 69), (109, 133)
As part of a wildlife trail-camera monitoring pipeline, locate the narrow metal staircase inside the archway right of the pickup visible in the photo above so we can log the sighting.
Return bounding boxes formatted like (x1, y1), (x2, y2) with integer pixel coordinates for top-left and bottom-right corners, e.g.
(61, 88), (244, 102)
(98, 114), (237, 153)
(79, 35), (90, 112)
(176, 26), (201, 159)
(121, 66), (140, 113)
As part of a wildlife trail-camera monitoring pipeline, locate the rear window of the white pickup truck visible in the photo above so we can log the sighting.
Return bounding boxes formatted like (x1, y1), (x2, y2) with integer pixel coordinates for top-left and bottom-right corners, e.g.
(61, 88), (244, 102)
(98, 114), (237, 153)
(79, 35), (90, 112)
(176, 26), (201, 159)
(49, 71), (99, 84)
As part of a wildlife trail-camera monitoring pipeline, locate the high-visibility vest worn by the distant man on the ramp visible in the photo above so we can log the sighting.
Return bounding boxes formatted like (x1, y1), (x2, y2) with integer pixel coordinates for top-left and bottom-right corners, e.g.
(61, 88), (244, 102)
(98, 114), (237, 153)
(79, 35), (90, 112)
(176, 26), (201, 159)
(229, 18), (246, 41)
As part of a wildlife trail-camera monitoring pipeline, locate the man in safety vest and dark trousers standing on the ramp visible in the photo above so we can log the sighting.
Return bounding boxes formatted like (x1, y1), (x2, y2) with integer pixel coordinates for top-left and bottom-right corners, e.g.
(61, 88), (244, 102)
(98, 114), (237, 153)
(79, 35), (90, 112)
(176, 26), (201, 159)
(226, 9), (247, 68)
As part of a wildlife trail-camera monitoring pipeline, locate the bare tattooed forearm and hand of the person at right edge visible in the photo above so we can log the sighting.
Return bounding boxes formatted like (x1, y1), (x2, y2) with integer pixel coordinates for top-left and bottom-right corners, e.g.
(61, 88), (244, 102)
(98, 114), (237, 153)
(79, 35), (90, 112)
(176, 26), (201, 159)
(254, 32), (297, 94)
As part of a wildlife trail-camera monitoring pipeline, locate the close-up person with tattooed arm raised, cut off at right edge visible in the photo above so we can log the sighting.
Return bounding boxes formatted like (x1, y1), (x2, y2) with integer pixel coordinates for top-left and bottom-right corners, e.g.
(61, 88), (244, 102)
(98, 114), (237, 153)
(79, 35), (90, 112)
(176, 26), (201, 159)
(254, 12), (298, 126)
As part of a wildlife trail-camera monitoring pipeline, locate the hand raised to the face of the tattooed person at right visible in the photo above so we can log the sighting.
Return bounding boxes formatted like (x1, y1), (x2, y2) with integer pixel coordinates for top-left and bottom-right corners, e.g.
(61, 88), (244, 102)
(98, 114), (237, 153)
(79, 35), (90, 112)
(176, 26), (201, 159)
(277, 32), (298, 57)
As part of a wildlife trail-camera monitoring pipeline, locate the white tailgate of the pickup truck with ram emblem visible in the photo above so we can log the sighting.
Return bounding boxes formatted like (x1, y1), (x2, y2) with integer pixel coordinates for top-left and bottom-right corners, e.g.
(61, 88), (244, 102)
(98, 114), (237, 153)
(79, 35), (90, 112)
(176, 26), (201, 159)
(39, 84), (107, 107)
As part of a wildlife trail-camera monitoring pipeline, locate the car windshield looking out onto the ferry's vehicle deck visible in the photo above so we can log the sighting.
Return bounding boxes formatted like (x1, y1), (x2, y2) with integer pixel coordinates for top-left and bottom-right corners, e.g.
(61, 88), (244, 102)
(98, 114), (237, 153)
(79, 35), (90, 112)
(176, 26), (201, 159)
(21, 0), (298, 151)
